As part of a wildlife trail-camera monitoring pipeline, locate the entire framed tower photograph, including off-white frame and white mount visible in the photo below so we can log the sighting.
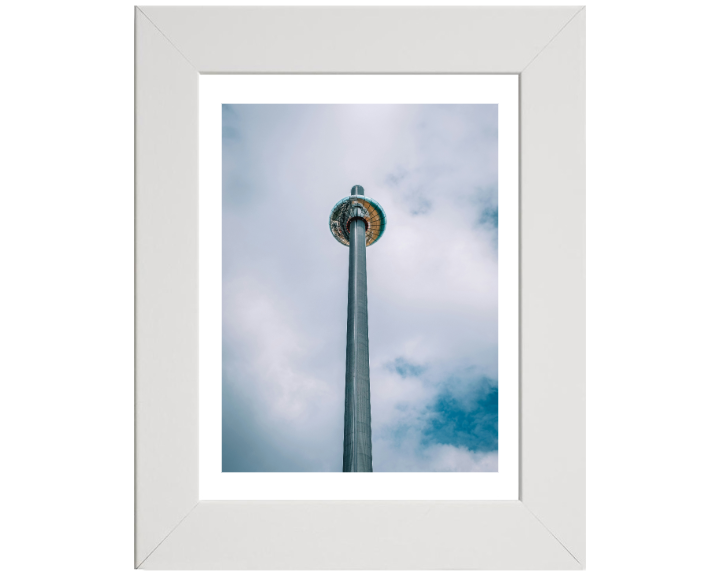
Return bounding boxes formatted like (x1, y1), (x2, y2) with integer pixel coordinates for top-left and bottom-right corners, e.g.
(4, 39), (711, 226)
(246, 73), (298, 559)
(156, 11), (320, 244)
(135, 7), (585, 569)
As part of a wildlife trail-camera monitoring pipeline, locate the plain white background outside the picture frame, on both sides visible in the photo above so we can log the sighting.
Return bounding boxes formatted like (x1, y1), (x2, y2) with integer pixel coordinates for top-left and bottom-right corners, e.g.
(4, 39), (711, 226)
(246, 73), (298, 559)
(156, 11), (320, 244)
(0, 0), (720, 575)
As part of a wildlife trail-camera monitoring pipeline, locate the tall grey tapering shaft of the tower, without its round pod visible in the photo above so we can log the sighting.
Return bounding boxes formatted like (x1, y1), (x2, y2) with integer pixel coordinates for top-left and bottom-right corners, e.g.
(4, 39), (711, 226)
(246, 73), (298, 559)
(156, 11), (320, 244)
(343, 216), (372, 472)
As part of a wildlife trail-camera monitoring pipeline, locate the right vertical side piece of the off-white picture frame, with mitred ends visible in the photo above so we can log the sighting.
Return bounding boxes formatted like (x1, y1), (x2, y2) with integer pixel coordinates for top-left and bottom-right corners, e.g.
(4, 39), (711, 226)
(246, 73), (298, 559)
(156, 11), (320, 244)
(520, 9), (585, 566)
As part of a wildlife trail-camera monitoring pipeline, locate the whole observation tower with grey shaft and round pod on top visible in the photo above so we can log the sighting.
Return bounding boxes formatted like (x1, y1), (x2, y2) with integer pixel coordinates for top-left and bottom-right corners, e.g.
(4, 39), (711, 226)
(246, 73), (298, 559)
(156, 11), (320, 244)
(330, 186), (387, 472)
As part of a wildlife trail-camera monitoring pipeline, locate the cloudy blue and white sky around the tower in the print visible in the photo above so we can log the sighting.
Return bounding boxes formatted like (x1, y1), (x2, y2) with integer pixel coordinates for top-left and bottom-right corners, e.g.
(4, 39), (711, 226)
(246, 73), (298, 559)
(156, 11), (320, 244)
(223, 104), (498, 472)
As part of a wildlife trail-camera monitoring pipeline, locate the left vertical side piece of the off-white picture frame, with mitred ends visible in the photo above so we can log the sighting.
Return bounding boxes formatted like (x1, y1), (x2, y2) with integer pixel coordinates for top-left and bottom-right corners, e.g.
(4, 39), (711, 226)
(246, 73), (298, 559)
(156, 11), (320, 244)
(135, 9), (199, 566)
